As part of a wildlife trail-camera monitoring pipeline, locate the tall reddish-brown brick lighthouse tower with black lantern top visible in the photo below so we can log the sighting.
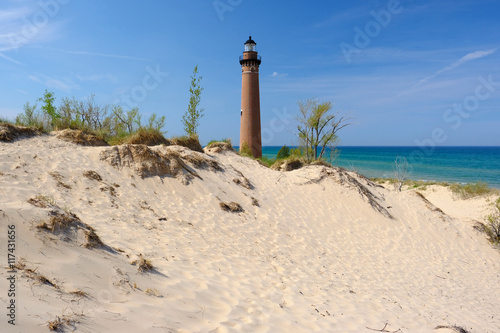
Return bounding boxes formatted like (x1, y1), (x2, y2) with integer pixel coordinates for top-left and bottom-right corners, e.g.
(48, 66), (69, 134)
(240, 36), (262, 157)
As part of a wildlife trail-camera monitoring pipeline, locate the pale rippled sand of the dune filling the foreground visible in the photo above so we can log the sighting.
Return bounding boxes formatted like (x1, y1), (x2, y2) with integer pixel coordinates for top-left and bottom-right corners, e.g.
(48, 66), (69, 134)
(0, 135), (500, 332)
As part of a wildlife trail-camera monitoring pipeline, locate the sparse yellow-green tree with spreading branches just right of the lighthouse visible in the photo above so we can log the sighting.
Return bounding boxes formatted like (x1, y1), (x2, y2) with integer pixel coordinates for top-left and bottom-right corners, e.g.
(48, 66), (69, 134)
(297, 99), (350, 162)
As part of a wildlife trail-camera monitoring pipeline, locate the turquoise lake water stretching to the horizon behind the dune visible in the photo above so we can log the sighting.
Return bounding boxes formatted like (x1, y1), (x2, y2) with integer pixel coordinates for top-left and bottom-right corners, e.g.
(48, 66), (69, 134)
(262, 146), (500, 189)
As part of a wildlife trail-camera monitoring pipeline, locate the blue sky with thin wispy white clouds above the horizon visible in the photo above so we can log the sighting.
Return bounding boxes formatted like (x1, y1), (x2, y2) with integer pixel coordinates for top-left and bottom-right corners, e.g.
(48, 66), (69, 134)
(0, 0), (500, 146)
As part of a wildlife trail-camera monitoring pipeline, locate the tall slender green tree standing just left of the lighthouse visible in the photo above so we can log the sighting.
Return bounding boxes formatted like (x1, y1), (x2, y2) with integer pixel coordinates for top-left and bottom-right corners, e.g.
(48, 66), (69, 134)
(182, 65), (204, 136)
